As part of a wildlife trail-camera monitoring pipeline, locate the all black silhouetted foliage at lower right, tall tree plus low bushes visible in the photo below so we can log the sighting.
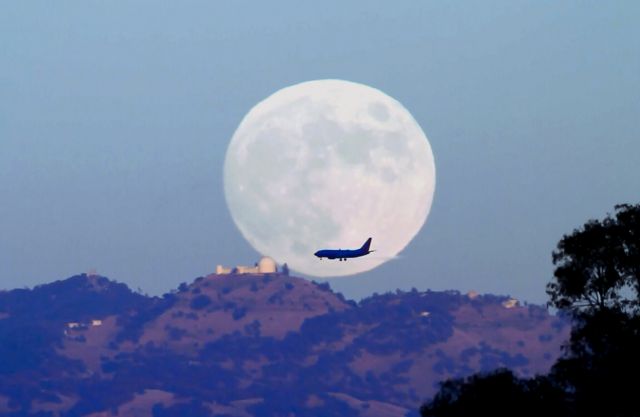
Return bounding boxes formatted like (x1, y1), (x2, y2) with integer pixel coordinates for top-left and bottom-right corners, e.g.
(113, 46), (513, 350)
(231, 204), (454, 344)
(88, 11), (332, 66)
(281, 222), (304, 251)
(420, 204), (640, 417)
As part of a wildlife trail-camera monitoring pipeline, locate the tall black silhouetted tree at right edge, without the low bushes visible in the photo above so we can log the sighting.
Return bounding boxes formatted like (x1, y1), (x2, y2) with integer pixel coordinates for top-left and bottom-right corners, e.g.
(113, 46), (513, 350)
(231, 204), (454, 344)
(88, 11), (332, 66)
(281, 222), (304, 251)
(547, 204), (640, 416)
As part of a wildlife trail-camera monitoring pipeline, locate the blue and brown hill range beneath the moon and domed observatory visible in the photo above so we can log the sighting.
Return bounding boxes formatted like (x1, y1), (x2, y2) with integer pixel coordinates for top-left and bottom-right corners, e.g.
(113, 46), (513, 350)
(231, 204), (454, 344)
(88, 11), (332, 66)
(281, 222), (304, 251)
(0, 274), (570, 417)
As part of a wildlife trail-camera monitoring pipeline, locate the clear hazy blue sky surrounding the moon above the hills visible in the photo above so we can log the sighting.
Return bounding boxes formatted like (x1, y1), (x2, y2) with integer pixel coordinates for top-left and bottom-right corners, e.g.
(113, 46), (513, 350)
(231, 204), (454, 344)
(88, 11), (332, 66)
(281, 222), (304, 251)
(0, 0), (640, 303)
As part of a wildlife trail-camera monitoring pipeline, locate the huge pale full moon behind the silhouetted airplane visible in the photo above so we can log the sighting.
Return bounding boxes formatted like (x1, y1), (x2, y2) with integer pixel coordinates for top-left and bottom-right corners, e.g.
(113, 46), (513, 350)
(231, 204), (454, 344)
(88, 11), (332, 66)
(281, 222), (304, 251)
(224, 80), (435, 277)
